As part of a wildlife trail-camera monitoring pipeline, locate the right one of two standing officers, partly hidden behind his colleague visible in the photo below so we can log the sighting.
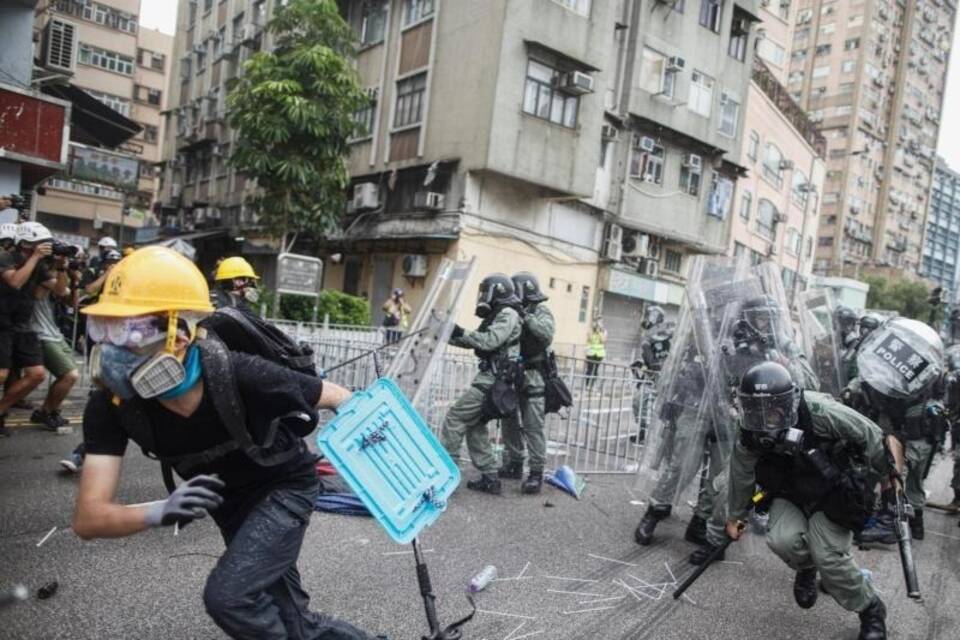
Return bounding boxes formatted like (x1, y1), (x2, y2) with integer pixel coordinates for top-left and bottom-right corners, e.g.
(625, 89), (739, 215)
(498, 271), (556, 494)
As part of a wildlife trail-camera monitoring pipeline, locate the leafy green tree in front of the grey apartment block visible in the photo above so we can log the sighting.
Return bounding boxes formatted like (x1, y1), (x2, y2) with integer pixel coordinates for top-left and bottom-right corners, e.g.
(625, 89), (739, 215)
(227, 0), (367, 250)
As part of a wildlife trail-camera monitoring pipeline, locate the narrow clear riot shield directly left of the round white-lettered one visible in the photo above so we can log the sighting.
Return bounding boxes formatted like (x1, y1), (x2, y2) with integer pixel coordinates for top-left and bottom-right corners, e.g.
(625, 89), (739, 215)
(798, 289), (848, 397)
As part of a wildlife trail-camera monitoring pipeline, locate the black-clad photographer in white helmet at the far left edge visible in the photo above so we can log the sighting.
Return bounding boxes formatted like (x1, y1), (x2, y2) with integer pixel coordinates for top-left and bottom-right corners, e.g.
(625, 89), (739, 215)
(0, 222), (56, 436)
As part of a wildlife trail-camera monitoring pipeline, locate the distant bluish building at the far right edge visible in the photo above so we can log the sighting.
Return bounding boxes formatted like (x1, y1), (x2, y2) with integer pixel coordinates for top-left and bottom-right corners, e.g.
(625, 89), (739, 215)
(921, 157), (960, 305)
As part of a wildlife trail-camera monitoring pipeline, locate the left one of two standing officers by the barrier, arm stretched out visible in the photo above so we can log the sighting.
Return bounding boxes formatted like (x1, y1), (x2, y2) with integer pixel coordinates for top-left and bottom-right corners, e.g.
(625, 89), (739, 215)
(442, 273), (521, 494)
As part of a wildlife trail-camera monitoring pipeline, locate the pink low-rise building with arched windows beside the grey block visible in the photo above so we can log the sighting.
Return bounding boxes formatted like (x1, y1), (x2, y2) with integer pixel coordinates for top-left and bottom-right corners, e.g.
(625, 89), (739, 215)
(729, 5), (826, 298)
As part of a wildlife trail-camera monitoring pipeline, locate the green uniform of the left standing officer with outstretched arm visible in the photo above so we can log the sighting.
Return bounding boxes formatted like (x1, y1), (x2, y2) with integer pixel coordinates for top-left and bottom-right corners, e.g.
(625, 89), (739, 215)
(441, 307), (520, 473)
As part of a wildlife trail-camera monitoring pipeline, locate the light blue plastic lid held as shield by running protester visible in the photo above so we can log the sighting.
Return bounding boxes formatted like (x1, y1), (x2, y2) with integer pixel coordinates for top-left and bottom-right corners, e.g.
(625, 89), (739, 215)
(317, 378), (460, 543)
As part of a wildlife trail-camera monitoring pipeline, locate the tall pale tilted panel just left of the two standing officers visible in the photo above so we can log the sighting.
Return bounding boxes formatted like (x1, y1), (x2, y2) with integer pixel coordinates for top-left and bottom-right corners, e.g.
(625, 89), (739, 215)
(385, 258), (476, 428)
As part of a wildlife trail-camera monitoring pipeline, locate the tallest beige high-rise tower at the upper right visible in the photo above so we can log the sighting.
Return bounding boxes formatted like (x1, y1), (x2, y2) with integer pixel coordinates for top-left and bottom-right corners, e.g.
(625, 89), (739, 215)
(772, 0), (956, 277)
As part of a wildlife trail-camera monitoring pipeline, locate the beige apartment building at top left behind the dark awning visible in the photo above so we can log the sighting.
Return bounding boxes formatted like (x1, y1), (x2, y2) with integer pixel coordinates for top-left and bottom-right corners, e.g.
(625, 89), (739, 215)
(35, 0), (173, 247)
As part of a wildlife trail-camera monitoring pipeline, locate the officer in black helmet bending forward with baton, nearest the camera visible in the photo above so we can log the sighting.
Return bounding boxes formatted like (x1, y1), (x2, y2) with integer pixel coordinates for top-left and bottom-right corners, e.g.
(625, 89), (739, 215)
(726, 362), (887, 640)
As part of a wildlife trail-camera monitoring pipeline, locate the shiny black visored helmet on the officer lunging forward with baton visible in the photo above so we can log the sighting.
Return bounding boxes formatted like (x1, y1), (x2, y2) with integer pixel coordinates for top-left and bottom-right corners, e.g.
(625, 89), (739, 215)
(737, 361), (800, 433)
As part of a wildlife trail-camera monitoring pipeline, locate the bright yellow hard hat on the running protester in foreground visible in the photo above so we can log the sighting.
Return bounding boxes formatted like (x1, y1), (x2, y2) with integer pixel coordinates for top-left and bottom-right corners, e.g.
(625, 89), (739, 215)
(82, 247), (213, 318)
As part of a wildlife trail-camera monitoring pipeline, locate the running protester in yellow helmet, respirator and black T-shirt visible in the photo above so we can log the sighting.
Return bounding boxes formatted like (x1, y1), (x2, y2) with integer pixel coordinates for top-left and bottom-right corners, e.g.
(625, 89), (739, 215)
(73, 247), (378, 640)
